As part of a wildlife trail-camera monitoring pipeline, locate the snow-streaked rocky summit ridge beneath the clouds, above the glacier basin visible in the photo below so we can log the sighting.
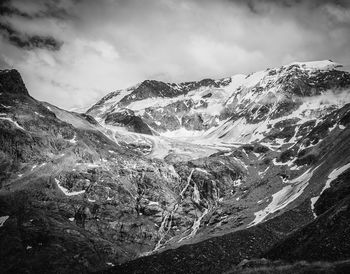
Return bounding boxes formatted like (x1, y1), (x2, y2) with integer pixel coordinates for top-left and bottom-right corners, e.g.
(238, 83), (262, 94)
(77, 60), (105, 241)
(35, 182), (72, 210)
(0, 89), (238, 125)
(87, 61), (350, 143)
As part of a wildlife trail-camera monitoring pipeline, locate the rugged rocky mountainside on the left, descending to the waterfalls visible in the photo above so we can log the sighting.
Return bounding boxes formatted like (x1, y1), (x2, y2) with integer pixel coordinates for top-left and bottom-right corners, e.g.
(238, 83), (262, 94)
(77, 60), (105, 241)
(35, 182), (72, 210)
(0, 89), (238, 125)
(0, 70), (186, 273)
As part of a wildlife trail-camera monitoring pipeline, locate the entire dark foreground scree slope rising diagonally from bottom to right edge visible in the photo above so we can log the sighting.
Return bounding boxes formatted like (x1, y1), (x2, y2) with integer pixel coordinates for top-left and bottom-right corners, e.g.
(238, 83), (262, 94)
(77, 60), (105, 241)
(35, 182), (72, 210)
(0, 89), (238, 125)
(106, 172), (350, 273)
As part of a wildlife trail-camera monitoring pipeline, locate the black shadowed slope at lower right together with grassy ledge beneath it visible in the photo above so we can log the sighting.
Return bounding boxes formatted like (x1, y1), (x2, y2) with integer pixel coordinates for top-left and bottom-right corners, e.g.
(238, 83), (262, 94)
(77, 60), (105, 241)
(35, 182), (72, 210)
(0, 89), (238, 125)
(224, 171), (350, 273)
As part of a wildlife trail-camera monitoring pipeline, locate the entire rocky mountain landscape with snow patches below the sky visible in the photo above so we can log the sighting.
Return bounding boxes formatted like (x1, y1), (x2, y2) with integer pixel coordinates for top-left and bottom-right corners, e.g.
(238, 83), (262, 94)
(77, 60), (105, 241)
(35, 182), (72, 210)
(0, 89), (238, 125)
(0, 61), (350, 273)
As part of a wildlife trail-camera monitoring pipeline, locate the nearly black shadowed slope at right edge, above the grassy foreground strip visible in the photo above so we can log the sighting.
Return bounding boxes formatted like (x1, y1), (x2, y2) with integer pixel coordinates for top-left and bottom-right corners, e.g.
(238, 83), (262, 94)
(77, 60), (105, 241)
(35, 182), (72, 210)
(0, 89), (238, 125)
(266, 171), (350, 261)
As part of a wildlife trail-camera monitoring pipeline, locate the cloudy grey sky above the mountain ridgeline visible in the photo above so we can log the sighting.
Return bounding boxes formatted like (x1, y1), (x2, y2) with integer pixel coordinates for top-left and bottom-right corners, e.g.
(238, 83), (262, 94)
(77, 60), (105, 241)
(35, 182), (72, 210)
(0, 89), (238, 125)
(0, 0), (350, 109)
